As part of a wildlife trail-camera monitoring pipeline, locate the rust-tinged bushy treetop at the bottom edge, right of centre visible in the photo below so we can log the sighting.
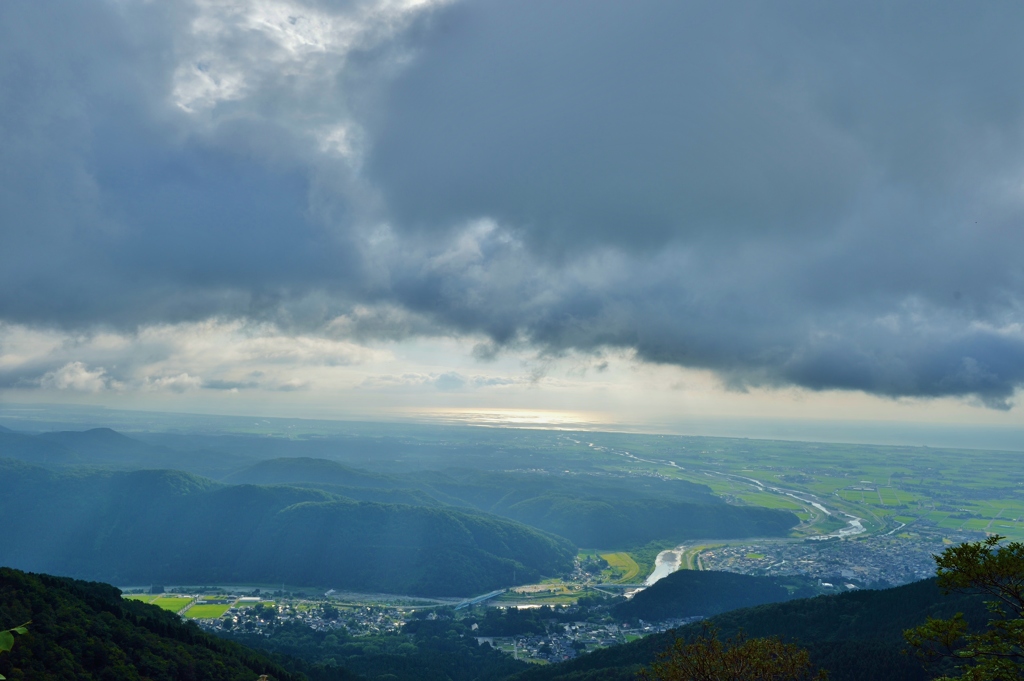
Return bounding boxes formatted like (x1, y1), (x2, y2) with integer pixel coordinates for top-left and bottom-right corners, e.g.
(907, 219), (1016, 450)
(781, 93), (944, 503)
(640, 625), (828, 681)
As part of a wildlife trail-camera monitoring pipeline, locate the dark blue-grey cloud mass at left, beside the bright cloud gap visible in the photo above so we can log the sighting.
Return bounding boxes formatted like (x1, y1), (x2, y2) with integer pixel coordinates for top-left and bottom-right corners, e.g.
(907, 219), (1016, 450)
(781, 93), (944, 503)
(0, 2), (356, 326)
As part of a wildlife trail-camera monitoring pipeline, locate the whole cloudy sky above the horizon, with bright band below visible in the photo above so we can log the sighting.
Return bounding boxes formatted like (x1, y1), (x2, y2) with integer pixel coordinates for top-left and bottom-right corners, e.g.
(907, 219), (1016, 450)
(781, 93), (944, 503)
(0, 0), (1024, 436)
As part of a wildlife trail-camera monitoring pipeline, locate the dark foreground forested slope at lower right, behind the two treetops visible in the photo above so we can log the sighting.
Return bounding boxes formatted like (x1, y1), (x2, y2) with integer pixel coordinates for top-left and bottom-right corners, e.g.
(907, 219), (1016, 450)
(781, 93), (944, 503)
(515, 579), (988, 681)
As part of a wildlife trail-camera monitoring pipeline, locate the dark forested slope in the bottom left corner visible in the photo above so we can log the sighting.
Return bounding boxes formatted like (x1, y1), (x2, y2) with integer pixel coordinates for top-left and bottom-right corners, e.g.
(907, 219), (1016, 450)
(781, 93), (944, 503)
(0, 568), (303, 681)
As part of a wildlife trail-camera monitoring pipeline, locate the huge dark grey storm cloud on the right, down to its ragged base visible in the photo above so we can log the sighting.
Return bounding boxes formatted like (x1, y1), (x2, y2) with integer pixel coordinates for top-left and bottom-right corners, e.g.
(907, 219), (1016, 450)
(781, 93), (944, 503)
(368, 2), (1024, 407)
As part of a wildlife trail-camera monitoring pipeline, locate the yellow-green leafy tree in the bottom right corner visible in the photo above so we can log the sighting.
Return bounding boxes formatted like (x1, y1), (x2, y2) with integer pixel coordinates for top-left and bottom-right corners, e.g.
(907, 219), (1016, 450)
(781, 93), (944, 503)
(903, 535), (1024, 681)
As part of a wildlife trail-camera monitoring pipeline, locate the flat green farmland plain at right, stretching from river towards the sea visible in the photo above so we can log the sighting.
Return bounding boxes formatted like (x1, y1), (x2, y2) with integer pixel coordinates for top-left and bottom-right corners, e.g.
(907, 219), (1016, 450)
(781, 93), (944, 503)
(563, 433), (1024, 541)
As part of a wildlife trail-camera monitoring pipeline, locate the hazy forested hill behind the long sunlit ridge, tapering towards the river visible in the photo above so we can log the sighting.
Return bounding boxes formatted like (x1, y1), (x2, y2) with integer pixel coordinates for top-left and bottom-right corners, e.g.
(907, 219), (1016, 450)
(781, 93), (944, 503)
(225, 457), (799, 547)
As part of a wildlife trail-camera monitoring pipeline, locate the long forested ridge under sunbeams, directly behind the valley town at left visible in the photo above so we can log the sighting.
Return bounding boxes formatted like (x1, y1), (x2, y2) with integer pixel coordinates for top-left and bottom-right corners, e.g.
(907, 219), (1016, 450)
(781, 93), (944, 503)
(0, 460), (575, 596)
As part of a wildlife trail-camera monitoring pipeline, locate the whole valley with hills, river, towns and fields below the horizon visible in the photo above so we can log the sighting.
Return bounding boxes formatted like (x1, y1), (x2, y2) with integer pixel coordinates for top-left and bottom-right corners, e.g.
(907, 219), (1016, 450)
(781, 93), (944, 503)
(0, 409), (1024, 679)
